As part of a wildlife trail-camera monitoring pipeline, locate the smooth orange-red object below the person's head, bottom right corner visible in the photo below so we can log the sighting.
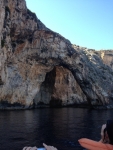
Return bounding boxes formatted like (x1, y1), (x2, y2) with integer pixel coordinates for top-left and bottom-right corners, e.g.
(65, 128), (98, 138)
(78, 138), (113, 150)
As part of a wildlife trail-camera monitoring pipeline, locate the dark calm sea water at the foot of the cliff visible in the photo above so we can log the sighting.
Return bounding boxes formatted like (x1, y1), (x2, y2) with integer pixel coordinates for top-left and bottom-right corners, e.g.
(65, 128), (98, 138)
(0, 108), (113, 150)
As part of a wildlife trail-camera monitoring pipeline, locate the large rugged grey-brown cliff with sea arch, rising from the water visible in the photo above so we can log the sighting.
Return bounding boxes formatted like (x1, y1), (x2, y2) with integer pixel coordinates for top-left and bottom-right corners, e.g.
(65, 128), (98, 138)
(0, 0), (113, 109)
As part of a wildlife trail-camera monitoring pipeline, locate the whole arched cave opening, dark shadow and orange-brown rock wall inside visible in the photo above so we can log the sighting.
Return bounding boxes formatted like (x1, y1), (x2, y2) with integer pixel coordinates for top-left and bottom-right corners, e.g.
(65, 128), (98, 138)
(34, 66), (87, 106)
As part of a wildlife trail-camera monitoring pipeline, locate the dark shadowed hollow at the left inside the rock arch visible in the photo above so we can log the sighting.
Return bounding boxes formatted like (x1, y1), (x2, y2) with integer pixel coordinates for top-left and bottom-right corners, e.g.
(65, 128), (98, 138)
(34, 67), (62, 107)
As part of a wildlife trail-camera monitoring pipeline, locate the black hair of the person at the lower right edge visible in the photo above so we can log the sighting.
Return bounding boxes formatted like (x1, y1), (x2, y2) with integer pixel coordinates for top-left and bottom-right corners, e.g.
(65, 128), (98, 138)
(106, 120), (113, 145)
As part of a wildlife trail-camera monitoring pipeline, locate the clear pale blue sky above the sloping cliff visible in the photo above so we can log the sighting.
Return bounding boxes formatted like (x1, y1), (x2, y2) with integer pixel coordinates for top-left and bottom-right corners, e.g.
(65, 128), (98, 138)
(26, 0), (113, 50)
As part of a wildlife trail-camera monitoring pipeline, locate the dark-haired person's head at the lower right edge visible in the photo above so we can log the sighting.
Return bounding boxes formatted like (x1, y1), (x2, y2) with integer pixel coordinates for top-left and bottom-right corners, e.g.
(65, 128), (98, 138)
(101, 120), (113, 145)
